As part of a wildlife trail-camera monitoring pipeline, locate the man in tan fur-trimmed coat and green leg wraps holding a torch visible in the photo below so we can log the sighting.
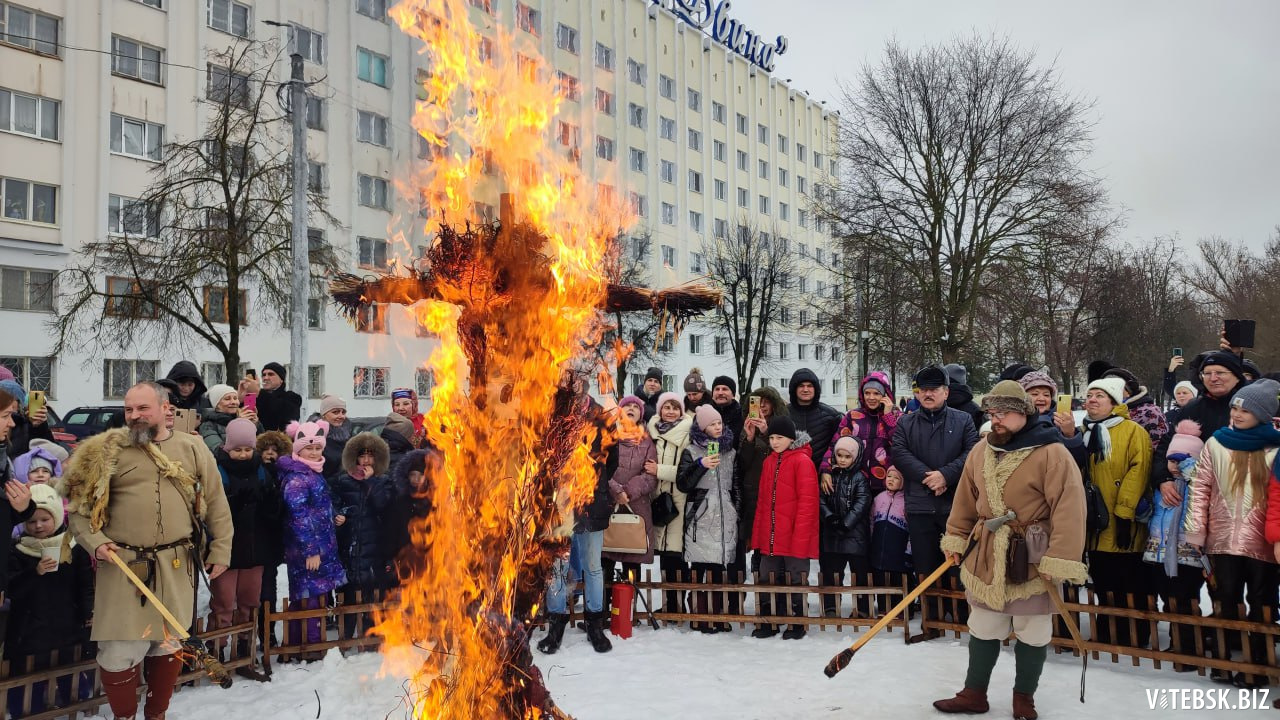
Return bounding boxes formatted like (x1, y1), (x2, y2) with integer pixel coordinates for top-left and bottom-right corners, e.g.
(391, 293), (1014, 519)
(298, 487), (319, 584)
(933, 380), (1085, 720)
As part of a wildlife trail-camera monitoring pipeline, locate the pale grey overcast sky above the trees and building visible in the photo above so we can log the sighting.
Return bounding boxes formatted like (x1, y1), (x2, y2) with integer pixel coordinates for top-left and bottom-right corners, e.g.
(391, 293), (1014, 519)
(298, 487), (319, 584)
(731, 0), (1280, 247)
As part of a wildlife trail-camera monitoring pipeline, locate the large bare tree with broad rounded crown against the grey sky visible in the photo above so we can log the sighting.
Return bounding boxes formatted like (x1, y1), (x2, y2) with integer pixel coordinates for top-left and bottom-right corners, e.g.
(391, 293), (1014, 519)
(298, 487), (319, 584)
(815, 37), (1106, 363)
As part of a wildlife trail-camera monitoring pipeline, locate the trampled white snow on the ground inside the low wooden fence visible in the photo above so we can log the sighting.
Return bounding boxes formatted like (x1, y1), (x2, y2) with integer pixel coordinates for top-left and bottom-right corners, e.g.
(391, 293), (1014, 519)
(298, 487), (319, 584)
(135, 617), (1276, 720)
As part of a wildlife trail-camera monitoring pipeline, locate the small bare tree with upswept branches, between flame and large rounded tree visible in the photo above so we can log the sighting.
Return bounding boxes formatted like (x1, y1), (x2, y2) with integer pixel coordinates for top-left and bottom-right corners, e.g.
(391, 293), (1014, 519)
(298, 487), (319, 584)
(703, 218), (797, 392)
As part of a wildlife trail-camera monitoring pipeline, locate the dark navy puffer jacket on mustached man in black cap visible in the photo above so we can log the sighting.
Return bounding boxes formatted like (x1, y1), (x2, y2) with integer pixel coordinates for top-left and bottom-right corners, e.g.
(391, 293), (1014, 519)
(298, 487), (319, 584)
(893, 407), (978, 515)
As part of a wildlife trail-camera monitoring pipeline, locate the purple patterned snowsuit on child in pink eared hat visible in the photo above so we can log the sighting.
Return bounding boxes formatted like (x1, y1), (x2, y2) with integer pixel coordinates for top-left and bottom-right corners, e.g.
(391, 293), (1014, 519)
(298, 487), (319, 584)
(275, 456), (347, 644)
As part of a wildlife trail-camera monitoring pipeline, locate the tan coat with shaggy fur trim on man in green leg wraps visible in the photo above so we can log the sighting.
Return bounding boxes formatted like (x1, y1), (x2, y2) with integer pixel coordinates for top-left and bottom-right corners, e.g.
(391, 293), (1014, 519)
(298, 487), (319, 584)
(941, 427), (1087, 615)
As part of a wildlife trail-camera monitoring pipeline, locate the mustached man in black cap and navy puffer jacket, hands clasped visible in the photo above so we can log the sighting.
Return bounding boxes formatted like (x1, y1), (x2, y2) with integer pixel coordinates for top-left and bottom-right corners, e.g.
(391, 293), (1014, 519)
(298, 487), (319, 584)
(893, 365), (978, 617)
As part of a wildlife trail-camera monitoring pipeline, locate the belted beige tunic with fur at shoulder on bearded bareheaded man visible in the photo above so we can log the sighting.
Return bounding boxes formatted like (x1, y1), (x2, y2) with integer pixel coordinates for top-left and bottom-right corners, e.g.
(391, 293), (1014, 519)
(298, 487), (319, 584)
(65, 430), (232, 642)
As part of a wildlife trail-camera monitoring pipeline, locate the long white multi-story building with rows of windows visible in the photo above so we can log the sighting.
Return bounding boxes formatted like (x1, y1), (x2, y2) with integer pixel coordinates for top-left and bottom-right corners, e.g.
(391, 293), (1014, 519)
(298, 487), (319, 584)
(0, 0), (847, 415)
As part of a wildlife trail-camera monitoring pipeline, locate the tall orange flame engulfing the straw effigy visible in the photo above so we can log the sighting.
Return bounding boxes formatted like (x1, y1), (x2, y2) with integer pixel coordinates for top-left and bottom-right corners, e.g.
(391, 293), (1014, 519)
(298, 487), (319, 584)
(374, 0), (626, 719)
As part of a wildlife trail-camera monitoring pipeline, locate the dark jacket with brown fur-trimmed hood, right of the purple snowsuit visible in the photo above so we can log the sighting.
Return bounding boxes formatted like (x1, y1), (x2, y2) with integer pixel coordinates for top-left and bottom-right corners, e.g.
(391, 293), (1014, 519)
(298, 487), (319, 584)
(330, 433), (396, 588)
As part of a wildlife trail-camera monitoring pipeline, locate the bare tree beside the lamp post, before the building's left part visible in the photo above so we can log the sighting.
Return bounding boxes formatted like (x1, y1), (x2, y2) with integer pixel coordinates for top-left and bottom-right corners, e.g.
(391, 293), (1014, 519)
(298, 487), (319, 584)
(51, 42), (338, 377)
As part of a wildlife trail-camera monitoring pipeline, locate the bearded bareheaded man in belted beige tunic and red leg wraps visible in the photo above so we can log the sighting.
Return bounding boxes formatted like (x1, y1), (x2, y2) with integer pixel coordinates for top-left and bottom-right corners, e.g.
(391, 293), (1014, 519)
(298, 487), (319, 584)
(64, 383), (233, 717)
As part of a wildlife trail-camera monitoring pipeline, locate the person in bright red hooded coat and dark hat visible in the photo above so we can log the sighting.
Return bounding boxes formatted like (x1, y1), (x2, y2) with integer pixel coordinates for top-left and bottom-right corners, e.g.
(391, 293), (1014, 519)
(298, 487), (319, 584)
(751, 416), (818, 639)
